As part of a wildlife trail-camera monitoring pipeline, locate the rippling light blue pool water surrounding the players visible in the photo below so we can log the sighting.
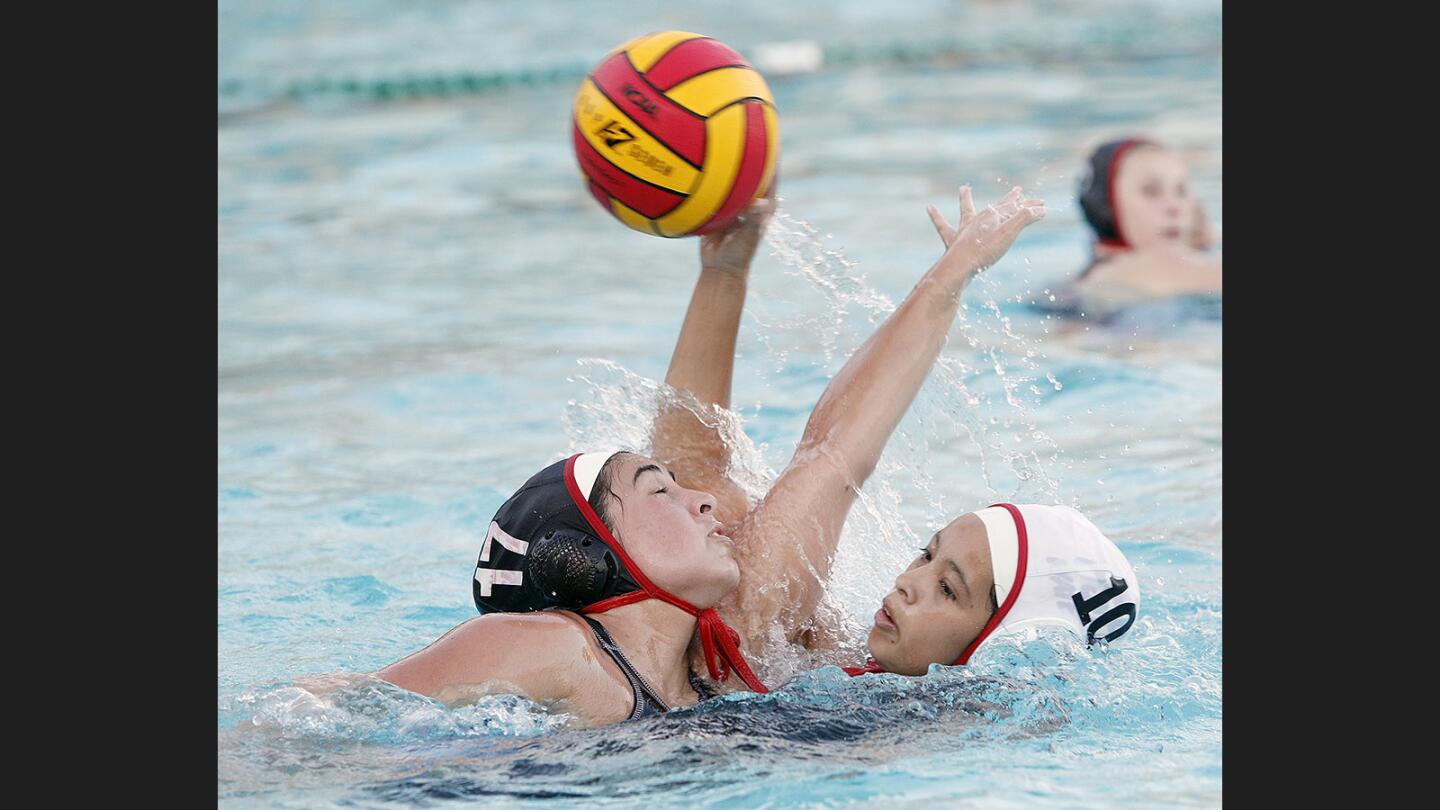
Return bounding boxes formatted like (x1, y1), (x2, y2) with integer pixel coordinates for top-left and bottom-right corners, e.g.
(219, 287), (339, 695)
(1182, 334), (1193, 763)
(217, 0), (1223, 807)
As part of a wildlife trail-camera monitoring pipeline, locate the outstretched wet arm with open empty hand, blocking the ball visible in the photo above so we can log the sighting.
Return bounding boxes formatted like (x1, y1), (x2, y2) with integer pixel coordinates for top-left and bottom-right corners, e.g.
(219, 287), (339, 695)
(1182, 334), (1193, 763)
(726, 187), (1044, 649)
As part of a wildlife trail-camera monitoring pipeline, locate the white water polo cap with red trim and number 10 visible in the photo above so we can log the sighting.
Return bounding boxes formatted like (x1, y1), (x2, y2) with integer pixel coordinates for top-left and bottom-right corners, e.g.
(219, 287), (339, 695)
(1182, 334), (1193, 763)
(955, 503), (1140, 664)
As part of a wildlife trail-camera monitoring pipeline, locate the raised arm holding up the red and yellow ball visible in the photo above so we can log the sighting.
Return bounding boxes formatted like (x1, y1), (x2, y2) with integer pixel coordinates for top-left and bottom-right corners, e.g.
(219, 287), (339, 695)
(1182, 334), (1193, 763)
(652, 183), (775, 530)
